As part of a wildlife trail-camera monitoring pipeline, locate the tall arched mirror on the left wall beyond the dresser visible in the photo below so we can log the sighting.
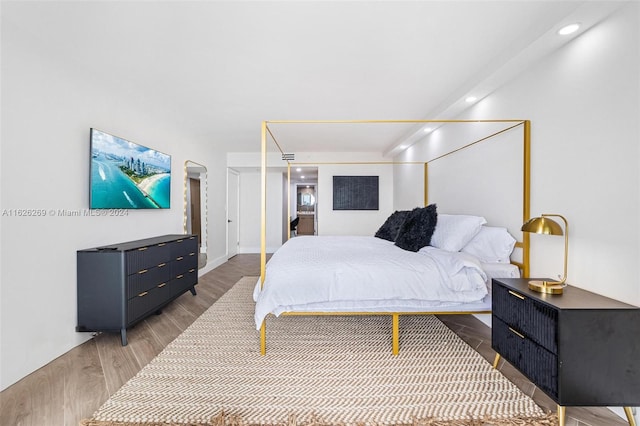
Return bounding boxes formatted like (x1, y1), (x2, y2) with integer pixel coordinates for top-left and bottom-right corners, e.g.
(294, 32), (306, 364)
(183, 160), (207, 268)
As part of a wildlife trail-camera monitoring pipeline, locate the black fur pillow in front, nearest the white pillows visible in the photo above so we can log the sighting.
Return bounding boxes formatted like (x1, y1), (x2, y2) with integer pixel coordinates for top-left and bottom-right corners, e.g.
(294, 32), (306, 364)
(395, 204), (438, 251)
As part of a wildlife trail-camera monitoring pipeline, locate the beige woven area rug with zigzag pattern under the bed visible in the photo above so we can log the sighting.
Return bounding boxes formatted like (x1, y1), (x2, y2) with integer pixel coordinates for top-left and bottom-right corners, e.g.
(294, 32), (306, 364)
(81, 277), (557, 426)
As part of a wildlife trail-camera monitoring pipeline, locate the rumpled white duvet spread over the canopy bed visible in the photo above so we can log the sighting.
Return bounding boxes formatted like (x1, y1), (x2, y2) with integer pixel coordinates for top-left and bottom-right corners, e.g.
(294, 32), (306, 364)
(253, 236), (487, 328)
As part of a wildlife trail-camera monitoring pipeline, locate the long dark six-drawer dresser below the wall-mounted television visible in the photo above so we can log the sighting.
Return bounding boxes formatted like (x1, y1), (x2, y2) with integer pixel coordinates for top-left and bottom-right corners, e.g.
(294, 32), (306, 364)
(76, 235), (198, 346)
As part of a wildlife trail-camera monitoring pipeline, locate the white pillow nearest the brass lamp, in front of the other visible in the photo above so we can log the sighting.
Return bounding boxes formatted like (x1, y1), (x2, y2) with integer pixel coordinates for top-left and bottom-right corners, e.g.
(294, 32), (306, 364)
(460, 226), (516, 263)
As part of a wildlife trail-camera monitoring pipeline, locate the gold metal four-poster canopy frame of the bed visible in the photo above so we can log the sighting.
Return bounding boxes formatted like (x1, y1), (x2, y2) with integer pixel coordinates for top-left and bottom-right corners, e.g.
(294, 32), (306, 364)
(255, 120), (531, 355)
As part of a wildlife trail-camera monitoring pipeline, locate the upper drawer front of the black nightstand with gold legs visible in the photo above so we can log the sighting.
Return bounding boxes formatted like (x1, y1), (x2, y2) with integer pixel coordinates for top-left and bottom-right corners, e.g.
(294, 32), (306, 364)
(492, 280), (558, 354)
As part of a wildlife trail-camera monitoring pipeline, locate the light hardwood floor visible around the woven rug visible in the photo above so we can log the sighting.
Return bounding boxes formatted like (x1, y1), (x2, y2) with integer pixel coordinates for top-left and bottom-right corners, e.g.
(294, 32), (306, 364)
(0, 254), (627, 426)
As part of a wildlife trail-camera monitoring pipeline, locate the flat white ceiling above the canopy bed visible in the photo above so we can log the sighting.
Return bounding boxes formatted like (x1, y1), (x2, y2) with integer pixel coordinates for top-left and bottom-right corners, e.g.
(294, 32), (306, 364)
(2, 1), (619, 154)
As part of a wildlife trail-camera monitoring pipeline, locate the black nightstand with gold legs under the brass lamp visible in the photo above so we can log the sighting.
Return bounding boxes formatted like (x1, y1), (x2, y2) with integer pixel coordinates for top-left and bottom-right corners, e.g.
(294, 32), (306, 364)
(491, 278), (640, 426)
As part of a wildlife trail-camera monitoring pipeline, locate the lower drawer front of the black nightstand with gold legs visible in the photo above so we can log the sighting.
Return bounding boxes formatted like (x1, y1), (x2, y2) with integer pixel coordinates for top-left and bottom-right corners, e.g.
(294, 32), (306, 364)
(491, 315), (558, 398)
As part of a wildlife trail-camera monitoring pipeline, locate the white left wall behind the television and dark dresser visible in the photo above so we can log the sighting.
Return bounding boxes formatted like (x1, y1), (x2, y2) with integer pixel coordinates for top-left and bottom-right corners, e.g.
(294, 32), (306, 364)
(0, 15), (226, 389)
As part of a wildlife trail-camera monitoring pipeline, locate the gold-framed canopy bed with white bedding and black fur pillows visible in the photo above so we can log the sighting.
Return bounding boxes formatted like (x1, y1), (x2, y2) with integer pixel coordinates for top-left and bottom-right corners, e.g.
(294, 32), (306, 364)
(254, 120), (530, 355)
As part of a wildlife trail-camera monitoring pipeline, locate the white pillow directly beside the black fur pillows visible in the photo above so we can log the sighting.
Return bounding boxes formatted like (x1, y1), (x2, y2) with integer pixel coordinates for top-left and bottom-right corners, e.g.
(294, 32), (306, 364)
(431, 214), (487, 251)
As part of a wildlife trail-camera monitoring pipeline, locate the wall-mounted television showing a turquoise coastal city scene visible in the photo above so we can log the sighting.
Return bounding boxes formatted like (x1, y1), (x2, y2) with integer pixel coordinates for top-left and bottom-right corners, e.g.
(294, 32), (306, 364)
(89, 128), (171, 209)
